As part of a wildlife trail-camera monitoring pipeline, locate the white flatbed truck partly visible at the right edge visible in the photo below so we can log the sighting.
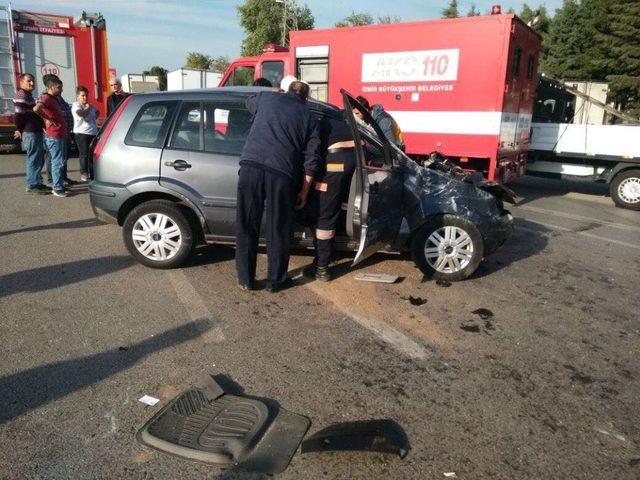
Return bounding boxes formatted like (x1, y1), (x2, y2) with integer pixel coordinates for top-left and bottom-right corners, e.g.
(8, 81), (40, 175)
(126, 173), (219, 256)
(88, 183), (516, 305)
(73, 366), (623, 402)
(527, 77), (640, 210)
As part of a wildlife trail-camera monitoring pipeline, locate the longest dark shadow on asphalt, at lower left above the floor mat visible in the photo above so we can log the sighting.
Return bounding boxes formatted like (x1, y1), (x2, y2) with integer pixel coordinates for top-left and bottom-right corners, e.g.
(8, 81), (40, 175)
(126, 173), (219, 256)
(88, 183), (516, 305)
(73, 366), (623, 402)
(0, 320), (213, 424)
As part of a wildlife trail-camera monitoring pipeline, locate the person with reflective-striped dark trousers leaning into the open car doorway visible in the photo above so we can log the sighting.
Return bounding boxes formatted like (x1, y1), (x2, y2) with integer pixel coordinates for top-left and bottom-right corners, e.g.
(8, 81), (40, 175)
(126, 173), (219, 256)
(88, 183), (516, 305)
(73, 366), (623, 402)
(306, 109), (356, 282)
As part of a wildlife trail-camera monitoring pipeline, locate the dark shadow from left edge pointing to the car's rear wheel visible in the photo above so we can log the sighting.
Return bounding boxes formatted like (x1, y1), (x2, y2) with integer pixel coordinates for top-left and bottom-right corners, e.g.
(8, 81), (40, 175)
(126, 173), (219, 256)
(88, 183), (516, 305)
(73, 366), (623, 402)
(0, 256), (134, 298)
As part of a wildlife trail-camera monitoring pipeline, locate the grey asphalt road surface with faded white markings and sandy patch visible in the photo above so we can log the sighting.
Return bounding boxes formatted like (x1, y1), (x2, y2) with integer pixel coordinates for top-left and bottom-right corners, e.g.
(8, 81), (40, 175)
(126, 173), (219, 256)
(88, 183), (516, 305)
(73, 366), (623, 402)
(0, 155), (640, 479)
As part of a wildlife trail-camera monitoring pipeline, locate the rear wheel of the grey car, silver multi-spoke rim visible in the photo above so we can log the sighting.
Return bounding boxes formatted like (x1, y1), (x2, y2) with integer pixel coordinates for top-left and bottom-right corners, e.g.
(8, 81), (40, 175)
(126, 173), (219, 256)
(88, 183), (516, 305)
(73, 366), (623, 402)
(122, 200), (194, 268)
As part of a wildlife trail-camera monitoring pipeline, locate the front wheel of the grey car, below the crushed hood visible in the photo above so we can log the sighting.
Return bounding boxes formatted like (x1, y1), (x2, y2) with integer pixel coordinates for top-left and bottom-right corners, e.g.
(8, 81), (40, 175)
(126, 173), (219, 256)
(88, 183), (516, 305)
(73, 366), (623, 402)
(411, 215), (484, 282)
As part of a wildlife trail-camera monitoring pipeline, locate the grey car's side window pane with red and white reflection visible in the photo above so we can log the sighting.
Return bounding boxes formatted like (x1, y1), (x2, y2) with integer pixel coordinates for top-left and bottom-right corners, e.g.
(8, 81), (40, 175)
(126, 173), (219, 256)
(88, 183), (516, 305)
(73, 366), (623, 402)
(203, 102), (253, 155)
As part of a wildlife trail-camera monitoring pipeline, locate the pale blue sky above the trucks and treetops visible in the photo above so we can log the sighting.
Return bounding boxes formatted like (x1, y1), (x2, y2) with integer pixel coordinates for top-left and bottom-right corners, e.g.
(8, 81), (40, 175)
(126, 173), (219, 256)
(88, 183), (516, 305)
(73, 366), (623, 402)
(11, 0), (562, 76)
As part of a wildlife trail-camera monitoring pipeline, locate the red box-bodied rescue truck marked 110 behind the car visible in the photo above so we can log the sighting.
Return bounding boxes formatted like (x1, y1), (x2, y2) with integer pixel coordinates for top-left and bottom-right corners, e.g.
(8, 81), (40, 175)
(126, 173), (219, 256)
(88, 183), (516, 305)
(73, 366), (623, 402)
(220, 14), (541, 182)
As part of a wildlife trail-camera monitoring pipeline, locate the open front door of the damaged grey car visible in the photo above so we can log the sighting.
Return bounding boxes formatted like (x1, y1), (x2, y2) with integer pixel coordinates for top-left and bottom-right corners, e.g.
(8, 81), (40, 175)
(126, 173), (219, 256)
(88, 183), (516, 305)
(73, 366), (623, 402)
(340, 90), (404, 265)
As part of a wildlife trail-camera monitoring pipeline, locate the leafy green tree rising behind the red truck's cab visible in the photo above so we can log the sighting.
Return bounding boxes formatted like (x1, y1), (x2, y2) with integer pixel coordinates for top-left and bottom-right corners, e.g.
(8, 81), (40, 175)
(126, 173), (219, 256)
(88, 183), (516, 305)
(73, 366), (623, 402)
(238, 0), (314, 55)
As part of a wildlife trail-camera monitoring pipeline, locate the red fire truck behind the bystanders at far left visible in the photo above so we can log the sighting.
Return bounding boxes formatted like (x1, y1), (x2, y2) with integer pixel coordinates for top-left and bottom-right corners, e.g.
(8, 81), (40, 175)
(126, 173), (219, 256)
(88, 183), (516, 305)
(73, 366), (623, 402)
(0, 7), (109, 148)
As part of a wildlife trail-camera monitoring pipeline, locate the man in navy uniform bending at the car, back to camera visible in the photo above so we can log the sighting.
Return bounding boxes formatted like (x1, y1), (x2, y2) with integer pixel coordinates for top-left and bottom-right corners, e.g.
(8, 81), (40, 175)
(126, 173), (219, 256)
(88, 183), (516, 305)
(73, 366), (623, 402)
(236, 81), (321, 292)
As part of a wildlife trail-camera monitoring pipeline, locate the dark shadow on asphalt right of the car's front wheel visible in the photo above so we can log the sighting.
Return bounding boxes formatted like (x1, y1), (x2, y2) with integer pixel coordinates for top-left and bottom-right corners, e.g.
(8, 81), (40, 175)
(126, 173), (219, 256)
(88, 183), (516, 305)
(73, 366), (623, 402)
(470, 218), (552, 279)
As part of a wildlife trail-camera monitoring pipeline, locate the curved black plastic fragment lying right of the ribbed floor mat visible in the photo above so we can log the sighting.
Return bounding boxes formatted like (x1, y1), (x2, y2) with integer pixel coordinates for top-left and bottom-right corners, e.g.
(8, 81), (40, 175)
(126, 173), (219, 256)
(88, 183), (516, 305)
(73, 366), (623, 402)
(302, 419), (411, 458)
